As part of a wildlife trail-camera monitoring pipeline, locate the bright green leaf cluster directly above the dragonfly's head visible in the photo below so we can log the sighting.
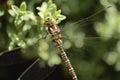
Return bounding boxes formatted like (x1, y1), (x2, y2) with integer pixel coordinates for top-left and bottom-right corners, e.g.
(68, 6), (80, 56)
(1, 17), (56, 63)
(37, 0), (66, 24)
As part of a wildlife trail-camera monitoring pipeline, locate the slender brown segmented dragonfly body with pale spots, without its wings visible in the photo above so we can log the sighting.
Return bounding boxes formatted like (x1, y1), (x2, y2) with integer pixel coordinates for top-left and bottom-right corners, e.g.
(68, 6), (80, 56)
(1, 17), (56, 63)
(45, 18), (78, 80)
